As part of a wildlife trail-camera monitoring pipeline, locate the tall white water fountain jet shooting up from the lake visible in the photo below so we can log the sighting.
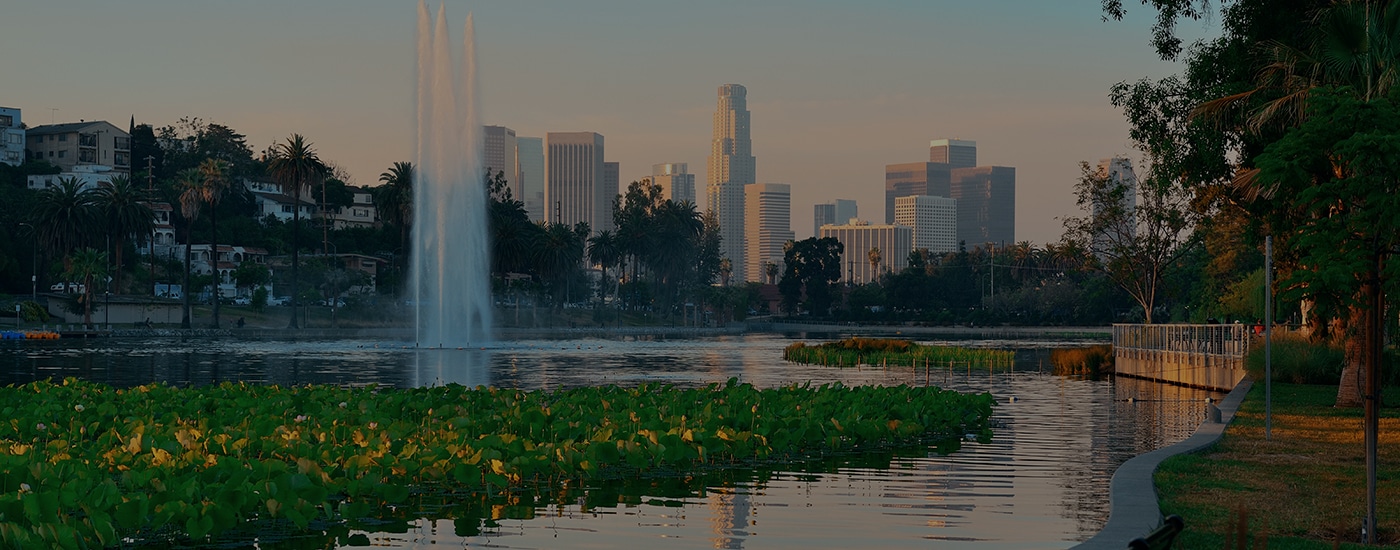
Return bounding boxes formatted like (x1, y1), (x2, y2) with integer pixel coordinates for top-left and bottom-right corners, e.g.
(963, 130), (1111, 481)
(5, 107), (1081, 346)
(409, 0), (491, 348)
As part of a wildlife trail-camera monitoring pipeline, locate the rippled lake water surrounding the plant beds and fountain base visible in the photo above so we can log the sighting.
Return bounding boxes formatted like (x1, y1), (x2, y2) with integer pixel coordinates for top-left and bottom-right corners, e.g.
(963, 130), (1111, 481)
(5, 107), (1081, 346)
(0, 334), (1221, 549)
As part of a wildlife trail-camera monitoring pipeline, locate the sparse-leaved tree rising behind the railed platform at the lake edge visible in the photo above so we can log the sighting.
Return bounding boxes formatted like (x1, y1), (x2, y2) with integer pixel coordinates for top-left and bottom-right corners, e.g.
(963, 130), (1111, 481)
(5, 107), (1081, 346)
(1064, 162), (1196, 325)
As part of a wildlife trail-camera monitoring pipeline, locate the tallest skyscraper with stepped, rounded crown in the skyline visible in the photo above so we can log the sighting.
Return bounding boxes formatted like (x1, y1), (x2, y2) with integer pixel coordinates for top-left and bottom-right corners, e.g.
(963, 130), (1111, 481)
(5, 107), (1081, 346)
(706, 84), (755, 282)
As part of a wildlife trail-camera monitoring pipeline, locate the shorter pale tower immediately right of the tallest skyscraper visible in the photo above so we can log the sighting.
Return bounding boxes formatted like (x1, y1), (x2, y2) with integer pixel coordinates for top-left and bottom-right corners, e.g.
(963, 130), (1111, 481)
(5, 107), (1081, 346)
(743, 183), (794, 283)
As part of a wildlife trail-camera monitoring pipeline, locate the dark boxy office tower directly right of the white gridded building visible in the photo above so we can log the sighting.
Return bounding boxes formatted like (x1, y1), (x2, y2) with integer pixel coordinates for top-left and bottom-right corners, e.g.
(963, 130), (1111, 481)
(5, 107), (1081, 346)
(952, 167), (1016, 249)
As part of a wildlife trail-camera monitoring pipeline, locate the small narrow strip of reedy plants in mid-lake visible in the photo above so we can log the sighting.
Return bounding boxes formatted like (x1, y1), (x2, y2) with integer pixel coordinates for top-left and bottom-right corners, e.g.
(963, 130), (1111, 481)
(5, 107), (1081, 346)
(783, 337), (1015, 367)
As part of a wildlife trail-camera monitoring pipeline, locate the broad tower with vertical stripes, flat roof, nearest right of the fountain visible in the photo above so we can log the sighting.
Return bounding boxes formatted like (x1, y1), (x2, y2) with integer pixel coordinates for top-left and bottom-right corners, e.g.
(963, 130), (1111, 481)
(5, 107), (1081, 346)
(545, 132), (612, 231)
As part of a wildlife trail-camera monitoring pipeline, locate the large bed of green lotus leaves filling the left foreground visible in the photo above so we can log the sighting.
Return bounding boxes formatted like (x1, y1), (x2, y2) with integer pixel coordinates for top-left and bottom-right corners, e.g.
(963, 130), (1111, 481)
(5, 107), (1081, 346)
(0, 379), (993, 547)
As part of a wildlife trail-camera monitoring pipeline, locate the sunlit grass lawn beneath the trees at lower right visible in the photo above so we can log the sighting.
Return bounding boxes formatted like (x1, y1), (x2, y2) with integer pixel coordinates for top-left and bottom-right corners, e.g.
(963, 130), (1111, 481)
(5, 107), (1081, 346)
(1155, 382), (1400, 549)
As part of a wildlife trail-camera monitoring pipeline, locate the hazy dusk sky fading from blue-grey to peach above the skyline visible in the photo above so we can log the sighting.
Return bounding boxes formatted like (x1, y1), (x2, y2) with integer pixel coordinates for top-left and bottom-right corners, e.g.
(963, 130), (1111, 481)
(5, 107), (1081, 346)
(0, 0), (1212, 244)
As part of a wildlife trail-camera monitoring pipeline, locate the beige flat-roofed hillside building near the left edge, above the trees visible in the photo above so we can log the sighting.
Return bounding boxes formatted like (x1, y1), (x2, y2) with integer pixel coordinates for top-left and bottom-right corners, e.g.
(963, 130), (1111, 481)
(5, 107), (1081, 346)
(24, 120), (132, 174)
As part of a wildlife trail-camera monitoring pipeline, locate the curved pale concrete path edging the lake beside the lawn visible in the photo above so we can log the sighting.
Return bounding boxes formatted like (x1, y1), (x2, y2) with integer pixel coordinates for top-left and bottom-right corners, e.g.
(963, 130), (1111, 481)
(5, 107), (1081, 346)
(1074, 378), (1252, 550)
